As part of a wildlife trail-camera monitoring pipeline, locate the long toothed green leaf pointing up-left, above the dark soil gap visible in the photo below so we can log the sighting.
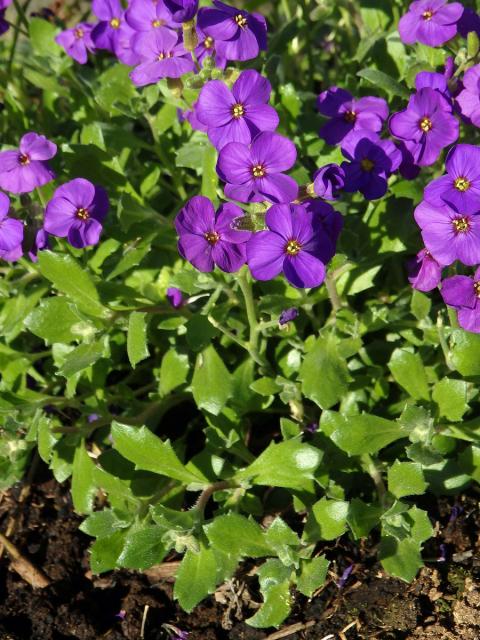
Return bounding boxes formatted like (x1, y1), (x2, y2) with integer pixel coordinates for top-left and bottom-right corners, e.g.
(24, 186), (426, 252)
(112, 422), (208, 486)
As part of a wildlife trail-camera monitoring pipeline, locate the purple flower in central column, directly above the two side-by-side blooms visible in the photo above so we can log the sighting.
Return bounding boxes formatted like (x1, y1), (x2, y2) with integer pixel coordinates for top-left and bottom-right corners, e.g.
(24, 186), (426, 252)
(217, 132), (298, 203)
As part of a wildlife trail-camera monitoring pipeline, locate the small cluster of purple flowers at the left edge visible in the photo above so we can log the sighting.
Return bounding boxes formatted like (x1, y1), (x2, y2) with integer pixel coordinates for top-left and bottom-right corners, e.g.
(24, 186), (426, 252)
(0, 132), (109, 261)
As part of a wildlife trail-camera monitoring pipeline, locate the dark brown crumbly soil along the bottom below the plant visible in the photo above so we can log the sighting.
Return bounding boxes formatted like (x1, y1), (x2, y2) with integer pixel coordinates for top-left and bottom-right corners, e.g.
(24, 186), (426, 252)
(0, 464), (480, 640)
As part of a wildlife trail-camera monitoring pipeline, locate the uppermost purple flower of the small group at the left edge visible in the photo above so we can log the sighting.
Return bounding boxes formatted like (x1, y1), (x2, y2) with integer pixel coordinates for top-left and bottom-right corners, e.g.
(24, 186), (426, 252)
(0, 132), (57, 193)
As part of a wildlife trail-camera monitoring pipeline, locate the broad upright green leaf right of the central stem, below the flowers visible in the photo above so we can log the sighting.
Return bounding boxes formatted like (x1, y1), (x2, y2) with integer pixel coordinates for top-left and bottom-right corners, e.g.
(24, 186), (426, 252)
(299, 336), (351, 409)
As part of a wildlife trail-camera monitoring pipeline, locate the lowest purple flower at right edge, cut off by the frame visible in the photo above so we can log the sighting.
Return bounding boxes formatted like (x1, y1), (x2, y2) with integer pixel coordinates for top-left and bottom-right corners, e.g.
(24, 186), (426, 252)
(441, 269), (480, 333)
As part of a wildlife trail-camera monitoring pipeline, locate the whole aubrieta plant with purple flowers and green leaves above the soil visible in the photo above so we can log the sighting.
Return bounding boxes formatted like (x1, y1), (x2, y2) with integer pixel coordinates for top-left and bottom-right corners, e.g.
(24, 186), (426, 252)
(0, 0), (480, 633)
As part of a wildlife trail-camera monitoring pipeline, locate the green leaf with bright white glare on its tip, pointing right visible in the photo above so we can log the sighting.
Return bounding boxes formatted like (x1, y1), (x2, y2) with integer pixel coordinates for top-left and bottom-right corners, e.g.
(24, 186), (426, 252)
(235, 440), (322, 489)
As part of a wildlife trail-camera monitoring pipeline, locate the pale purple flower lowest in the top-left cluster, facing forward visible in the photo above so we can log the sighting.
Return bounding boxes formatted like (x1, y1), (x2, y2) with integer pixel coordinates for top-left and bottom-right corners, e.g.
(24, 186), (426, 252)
(130, 29), (195, 87)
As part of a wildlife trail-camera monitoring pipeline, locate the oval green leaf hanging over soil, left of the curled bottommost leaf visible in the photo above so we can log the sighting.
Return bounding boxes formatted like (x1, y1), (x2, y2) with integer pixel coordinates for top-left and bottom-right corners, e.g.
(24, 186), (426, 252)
(173, 545), (217, 613)
